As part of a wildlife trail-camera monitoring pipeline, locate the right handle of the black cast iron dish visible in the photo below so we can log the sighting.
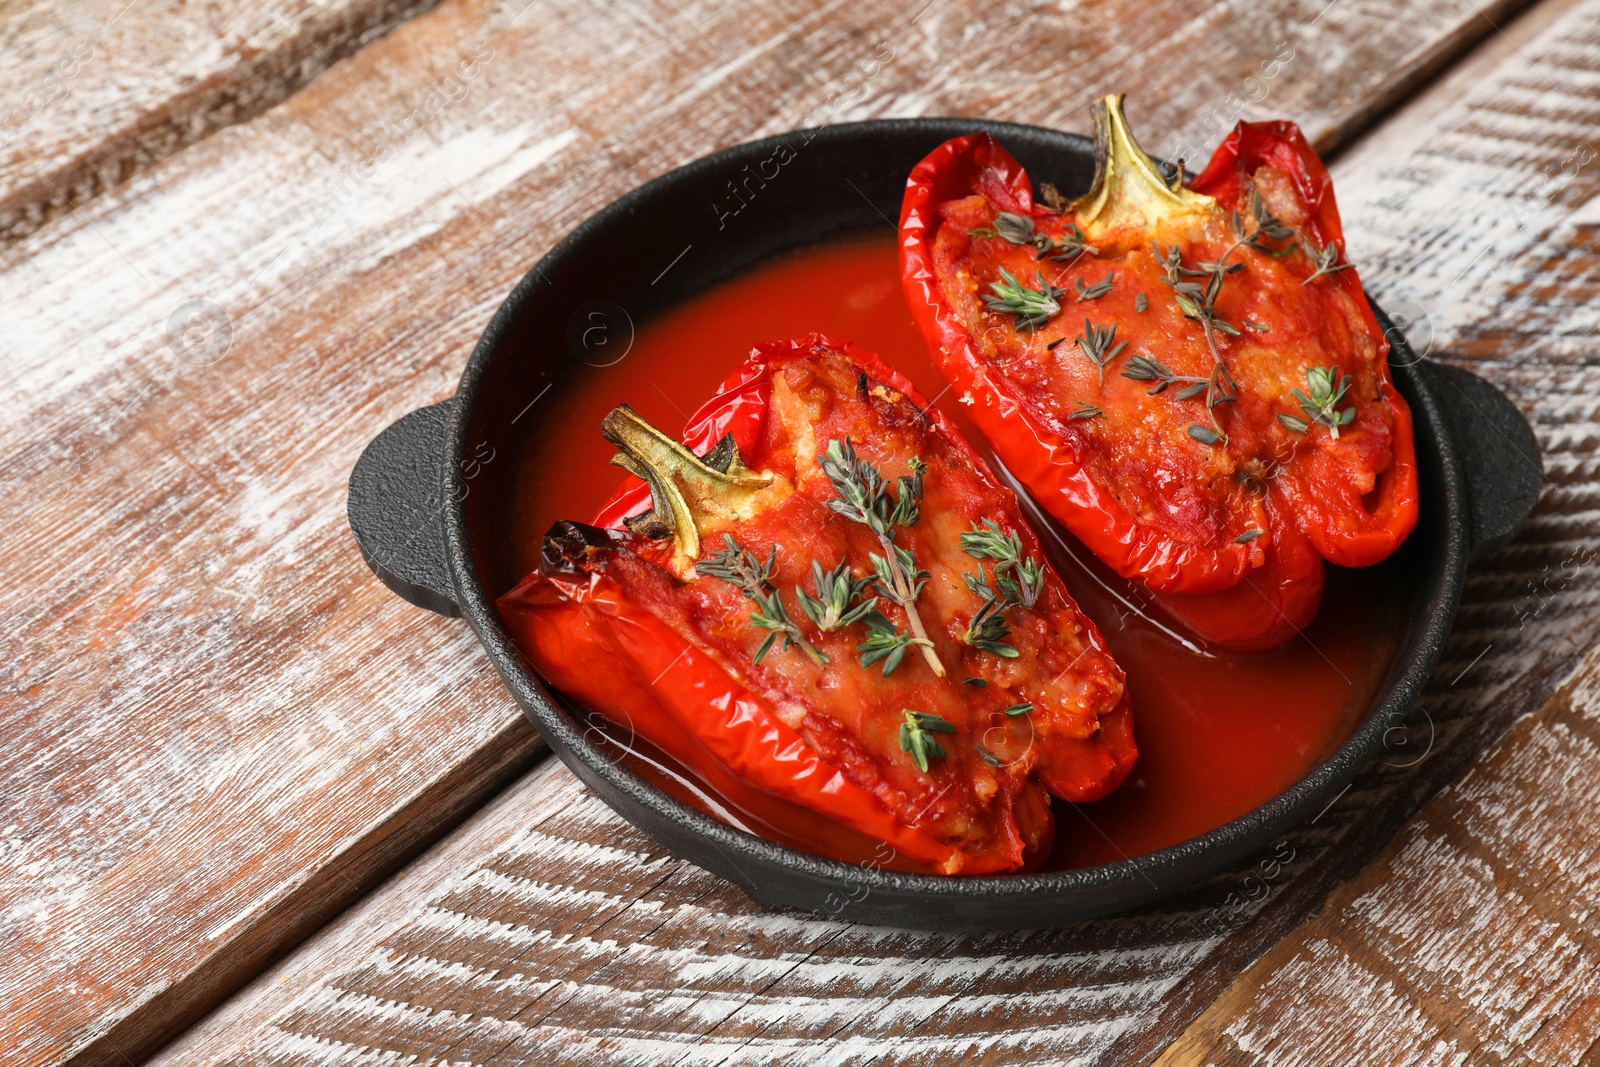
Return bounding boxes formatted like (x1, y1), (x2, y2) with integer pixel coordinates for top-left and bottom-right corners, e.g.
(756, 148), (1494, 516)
(1414, 360), (1544, 563)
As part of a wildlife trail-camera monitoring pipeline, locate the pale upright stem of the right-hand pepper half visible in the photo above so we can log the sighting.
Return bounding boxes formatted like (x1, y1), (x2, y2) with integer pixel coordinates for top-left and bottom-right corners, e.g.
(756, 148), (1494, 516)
(1069, 93), (1219, 237)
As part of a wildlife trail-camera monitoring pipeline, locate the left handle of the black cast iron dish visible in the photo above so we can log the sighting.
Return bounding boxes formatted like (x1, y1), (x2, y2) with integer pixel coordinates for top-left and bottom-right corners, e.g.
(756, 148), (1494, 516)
(347, 397), (461, 619)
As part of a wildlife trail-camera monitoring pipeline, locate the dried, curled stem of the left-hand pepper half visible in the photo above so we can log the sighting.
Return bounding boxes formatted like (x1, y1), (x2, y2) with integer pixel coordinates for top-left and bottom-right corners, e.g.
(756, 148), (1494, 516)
(600, 403), (773, 569)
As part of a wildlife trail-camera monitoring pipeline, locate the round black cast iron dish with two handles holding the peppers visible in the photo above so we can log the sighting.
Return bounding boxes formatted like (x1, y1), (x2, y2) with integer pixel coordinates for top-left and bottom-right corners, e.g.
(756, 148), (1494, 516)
(349, 118), (1542, 929)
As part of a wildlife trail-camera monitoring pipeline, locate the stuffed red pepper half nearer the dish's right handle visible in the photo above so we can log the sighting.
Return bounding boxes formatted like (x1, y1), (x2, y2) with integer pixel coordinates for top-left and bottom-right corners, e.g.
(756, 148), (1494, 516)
(901, 96), (1416, 651)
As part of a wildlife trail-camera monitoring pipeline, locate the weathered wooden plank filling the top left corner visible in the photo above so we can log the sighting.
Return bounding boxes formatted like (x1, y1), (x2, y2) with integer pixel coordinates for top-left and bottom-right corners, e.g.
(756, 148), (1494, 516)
(0, 0), (438, 240)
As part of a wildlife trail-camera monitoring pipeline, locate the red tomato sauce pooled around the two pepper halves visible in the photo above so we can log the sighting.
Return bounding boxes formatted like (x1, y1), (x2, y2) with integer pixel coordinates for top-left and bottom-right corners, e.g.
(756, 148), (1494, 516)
(512, 232), (1403, 869)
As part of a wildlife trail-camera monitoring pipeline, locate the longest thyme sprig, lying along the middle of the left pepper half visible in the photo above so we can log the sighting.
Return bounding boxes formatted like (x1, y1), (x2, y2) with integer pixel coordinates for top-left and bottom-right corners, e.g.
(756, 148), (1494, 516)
(818, 437), (944, 678)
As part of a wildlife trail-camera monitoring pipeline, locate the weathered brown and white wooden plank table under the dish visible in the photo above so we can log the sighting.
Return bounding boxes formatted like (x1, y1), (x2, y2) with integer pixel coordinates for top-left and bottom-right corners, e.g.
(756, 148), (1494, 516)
(0, 0), (1600, 1065)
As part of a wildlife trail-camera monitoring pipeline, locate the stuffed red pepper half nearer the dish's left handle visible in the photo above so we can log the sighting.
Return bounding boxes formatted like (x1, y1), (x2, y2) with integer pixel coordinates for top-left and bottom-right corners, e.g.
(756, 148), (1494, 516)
(499, 336), (1136, 873)
